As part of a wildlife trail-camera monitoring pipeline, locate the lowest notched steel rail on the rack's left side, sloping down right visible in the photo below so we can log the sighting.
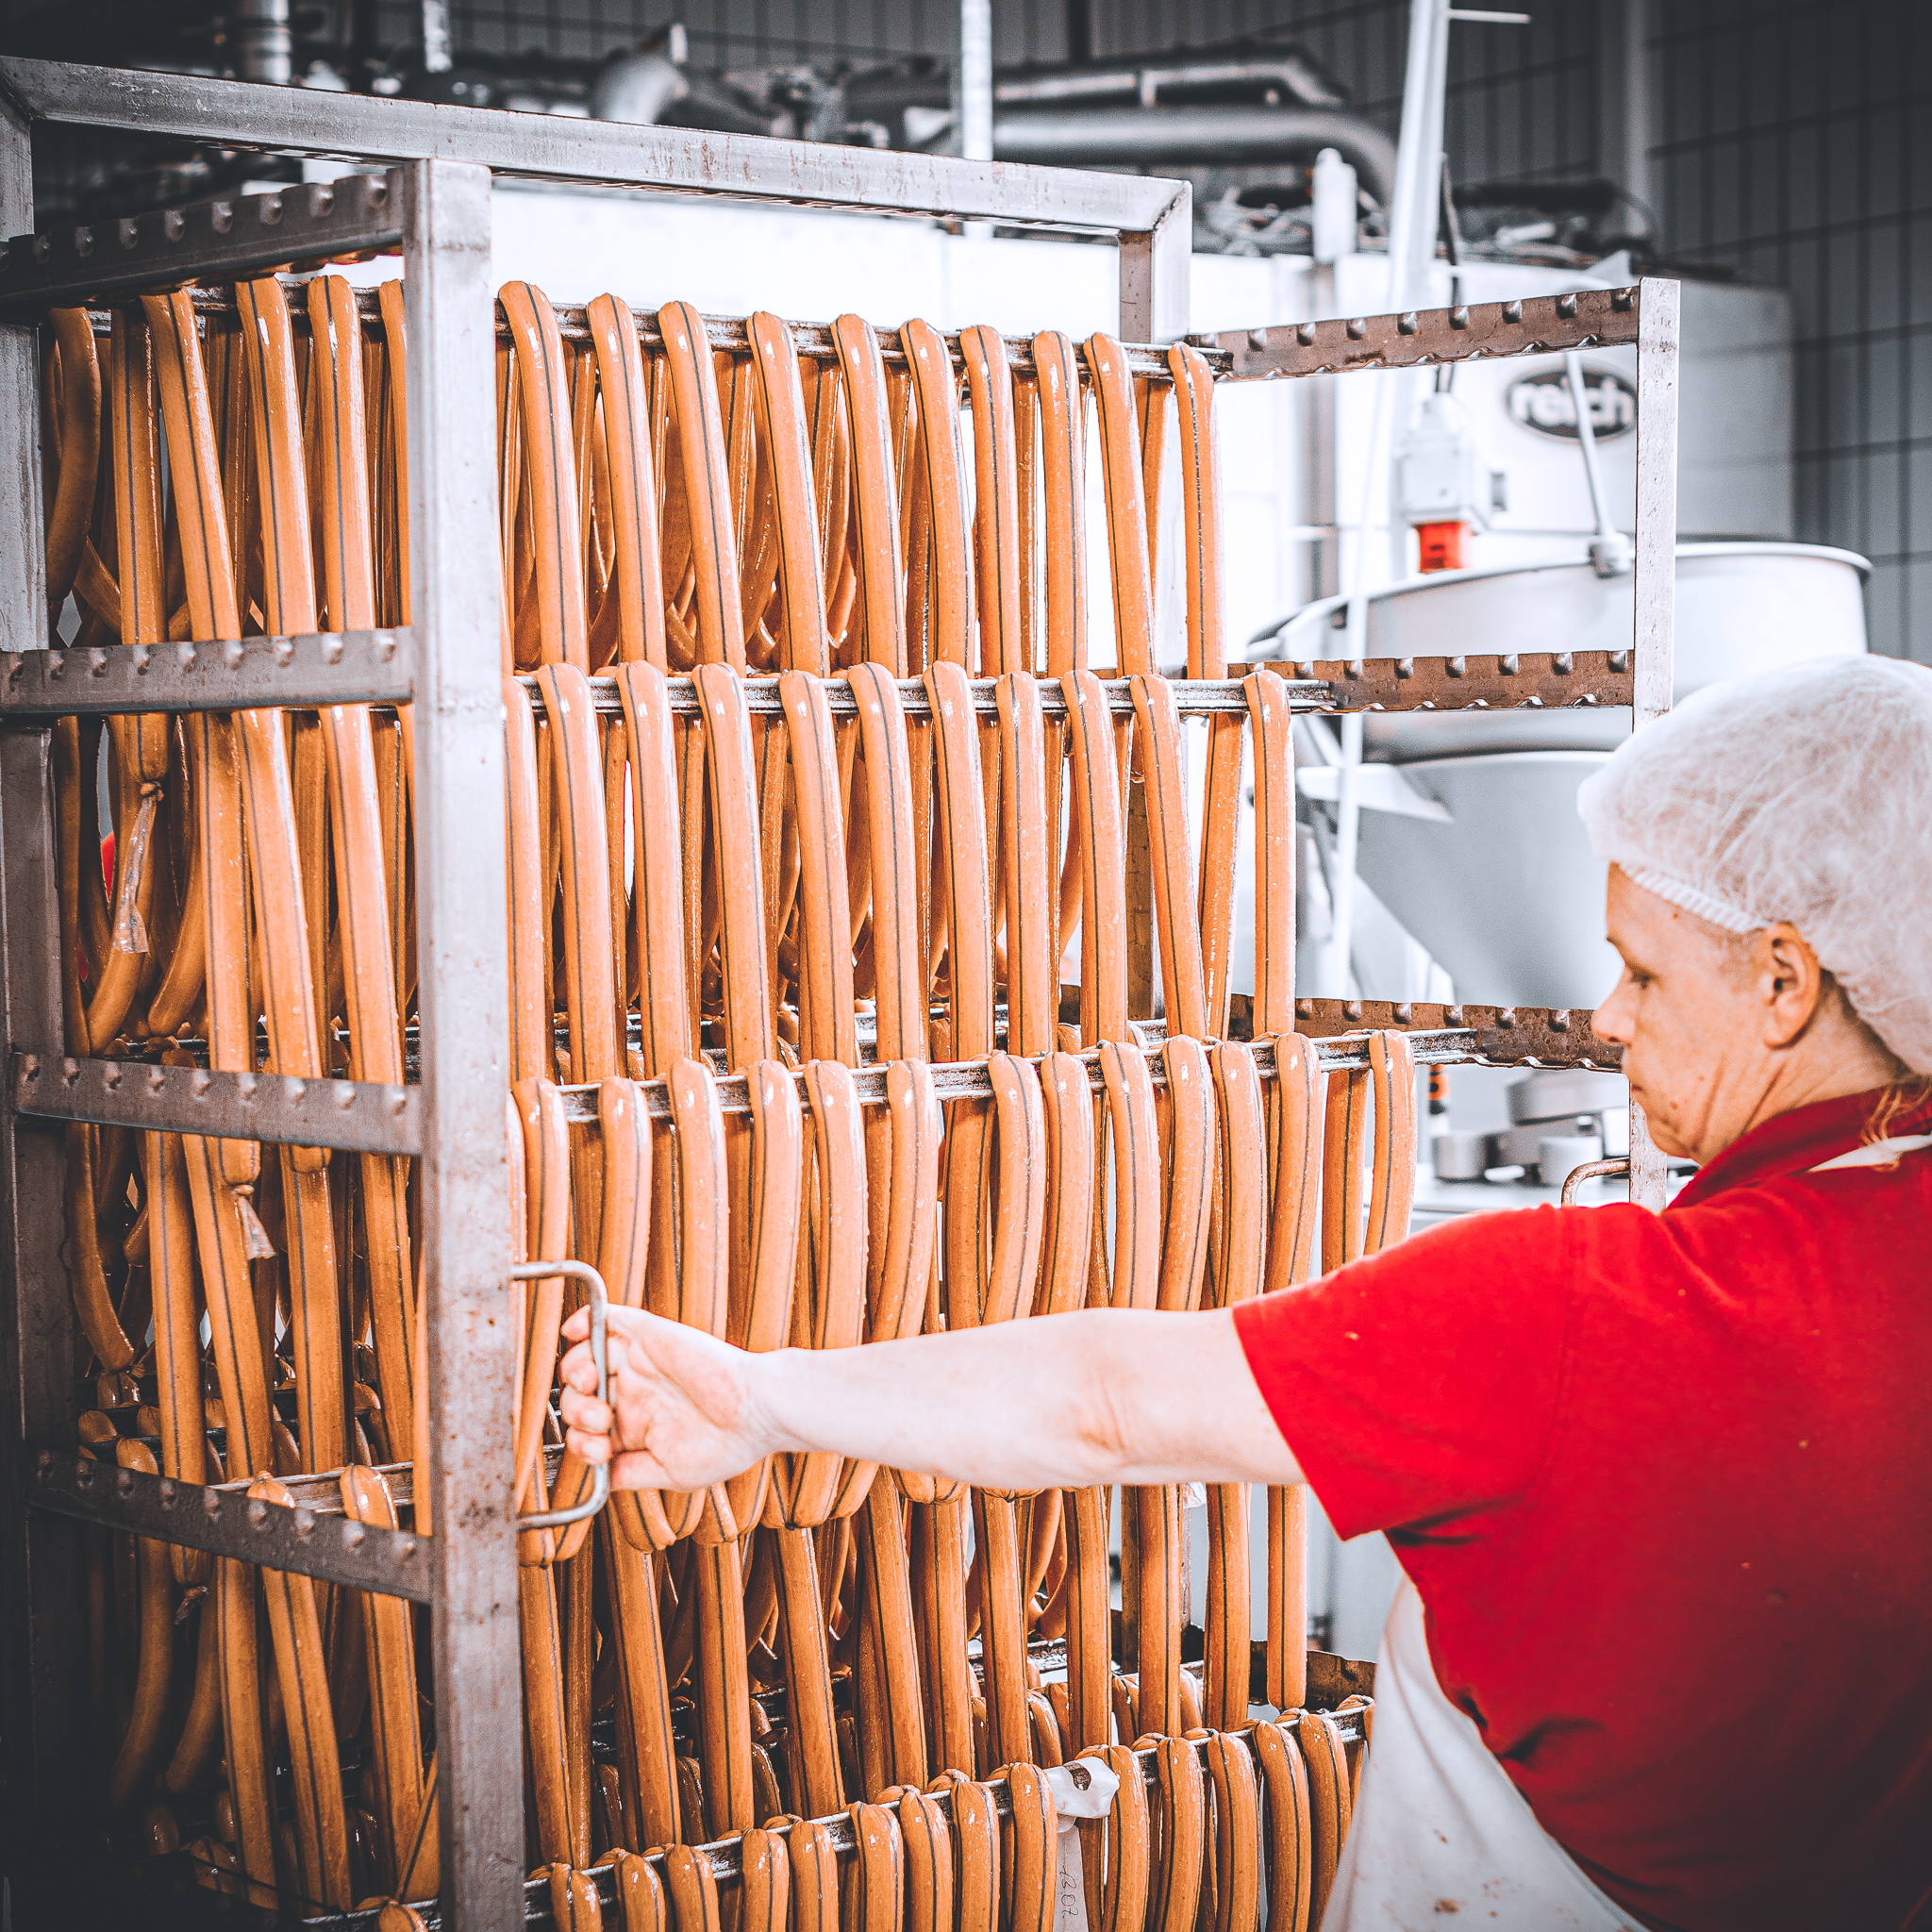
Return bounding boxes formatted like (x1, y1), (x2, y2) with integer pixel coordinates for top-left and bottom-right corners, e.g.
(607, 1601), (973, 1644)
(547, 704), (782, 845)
(27, 1449), (429, 1604)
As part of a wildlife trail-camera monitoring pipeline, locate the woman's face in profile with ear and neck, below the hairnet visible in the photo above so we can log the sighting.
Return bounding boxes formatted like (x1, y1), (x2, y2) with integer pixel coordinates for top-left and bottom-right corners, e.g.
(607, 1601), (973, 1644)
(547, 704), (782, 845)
(1594, 866), (1895, 1161)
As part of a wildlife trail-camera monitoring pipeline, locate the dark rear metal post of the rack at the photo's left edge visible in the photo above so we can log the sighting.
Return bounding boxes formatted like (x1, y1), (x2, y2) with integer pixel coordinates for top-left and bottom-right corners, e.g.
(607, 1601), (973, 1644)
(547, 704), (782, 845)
(0, 87), (85, 1825)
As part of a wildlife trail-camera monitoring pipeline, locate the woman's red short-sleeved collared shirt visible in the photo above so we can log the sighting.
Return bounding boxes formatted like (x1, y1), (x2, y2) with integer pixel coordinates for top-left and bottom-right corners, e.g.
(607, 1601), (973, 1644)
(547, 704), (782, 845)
(1237, 1093), (1932, 1932)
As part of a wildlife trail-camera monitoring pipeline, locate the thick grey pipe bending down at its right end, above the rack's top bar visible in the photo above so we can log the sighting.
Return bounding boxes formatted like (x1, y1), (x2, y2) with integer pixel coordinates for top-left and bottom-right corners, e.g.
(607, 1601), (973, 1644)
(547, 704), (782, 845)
(993, 107), (1395, 207)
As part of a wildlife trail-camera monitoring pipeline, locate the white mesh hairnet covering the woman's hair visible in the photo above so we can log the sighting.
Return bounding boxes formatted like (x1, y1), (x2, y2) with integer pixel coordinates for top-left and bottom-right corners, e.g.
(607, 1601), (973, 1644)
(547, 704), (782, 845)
(1576, 657), (1932, 1073)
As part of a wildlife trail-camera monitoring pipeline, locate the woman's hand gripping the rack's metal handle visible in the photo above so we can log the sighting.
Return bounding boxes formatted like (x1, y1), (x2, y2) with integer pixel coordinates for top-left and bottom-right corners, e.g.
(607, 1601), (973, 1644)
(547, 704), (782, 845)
(562, 1307), (787, 1490)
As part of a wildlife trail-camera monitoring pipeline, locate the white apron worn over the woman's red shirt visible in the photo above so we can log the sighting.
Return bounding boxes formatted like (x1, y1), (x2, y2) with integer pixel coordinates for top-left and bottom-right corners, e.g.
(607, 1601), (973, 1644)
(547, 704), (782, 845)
(1322, 1134), (1932, 1932)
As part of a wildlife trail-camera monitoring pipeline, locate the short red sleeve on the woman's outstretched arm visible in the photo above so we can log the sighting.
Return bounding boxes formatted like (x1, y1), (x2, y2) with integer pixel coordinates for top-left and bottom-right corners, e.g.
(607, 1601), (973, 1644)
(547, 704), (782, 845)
(1235, 1208), (1591, 1540)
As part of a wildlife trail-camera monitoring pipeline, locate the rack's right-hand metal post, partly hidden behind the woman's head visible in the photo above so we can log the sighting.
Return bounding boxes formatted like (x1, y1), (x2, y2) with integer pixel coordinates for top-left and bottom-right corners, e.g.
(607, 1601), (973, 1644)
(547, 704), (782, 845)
(1631, 276), (1679, 1211)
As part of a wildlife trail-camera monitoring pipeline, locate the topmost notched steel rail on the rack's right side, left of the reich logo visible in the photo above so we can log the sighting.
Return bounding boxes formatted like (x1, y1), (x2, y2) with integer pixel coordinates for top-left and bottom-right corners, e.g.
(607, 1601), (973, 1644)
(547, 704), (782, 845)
(1200, 280), (1638, 383)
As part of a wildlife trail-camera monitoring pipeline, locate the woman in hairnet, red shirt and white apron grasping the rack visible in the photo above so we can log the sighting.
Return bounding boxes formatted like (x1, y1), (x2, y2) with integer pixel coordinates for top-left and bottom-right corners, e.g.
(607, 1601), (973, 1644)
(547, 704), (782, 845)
(564, 658), (1932, 1932)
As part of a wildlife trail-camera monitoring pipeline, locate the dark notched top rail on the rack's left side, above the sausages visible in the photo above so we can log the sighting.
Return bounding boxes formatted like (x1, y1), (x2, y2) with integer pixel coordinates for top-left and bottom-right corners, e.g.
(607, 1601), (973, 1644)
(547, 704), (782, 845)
(0, 172), (402, 315)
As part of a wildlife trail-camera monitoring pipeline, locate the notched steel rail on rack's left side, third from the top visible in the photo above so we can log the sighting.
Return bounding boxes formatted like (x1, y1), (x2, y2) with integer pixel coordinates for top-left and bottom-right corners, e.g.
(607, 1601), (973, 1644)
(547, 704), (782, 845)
(8, 1053), (425, 1156)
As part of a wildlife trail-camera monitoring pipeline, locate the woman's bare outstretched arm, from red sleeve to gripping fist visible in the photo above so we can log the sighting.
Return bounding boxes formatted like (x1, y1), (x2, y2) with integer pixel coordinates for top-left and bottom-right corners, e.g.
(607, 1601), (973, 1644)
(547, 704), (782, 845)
(564, 1307), (1302, 1490)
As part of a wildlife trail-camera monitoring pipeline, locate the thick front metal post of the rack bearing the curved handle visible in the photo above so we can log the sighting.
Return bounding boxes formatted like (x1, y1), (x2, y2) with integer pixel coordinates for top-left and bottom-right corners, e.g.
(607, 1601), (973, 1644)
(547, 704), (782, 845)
(404, 160), (524, 1932)
